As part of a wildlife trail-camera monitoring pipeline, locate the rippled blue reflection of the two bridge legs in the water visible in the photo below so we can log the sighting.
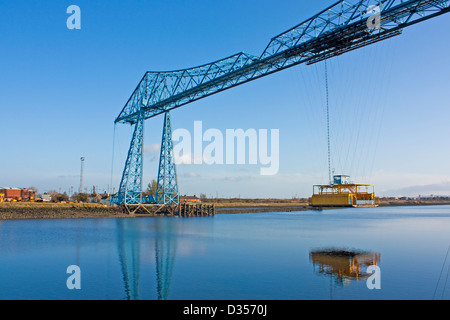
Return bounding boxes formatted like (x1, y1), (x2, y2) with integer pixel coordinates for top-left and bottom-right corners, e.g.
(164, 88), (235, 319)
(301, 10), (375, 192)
(117, 218), (177, 300)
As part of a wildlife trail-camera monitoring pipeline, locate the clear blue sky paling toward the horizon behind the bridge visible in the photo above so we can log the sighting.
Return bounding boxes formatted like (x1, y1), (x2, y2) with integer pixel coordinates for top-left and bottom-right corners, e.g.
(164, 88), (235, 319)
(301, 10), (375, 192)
(0, 0), (450, 198)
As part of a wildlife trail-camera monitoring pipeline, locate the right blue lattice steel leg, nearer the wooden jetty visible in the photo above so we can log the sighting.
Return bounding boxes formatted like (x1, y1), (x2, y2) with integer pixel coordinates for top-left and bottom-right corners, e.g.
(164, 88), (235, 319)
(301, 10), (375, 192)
(156, 111), (180, 205)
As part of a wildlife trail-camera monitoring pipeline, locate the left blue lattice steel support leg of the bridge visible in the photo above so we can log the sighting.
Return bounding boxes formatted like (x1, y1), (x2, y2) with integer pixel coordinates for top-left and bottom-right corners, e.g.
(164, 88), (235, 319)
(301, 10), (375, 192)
(117, 114), (144, 205)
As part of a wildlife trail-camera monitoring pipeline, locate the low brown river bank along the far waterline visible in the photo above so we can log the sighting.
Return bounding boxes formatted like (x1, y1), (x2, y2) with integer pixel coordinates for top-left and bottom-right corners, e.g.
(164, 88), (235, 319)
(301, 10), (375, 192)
(0, 199), (450, 221)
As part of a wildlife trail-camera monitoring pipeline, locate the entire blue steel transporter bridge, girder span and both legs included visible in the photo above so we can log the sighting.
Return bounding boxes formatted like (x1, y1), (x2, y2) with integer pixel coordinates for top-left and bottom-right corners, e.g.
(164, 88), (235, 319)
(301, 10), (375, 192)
(113, 0), (450, 205)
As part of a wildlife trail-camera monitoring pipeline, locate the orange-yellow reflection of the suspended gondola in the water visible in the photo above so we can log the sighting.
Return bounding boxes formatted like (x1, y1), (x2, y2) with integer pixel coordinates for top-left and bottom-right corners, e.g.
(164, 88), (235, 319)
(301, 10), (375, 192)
(310, 248), (380, 285)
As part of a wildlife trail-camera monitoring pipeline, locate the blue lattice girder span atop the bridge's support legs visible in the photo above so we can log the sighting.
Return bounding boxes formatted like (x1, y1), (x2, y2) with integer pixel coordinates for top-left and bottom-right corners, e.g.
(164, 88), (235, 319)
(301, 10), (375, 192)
(115, 0), (450, 124)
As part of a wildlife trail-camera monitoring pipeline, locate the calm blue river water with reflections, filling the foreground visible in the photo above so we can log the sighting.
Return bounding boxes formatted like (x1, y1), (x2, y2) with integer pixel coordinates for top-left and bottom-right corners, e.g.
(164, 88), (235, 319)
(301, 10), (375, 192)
(0, 206), (450, 300)
